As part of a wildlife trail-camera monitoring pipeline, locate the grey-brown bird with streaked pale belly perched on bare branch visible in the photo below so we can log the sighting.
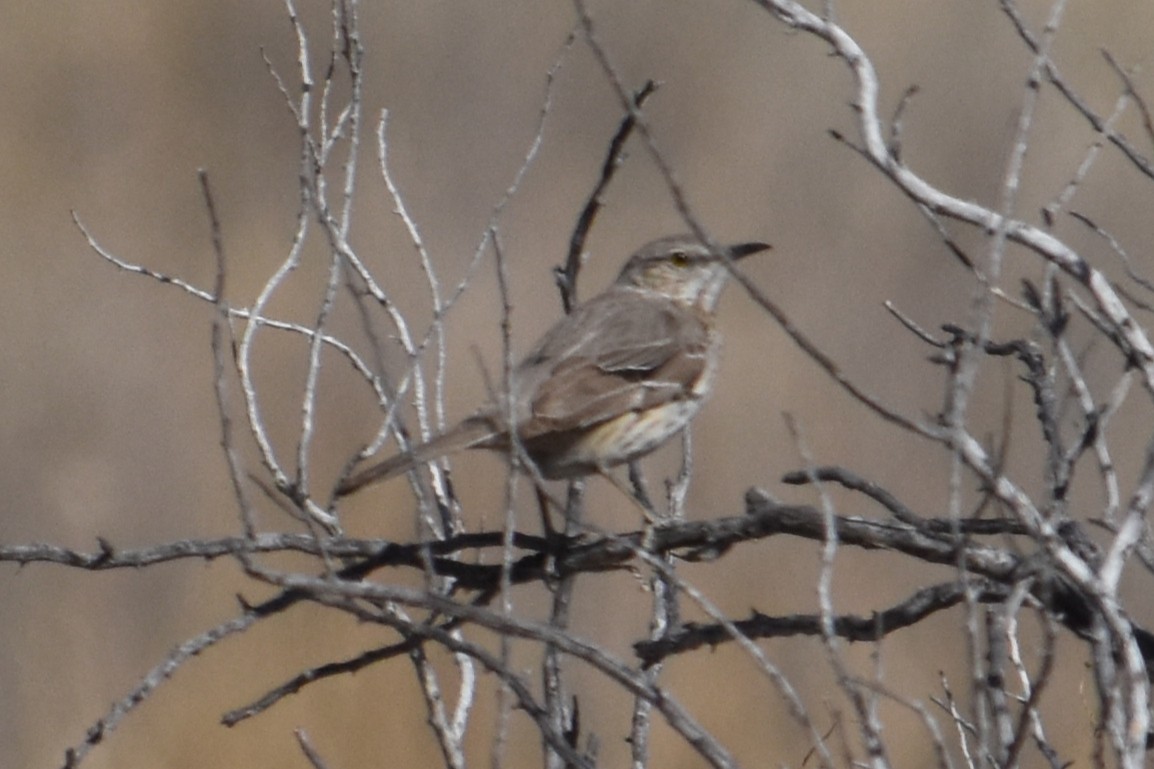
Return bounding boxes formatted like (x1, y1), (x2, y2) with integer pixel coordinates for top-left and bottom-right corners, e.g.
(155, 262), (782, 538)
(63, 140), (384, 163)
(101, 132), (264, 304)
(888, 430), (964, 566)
(336, 234), (770, 498)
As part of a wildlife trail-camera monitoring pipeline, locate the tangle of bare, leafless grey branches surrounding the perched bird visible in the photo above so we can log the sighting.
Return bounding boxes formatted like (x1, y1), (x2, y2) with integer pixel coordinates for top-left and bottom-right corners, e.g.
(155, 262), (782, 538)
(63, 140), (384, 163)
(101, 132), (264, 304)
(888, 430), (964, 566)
(15, 0), (1154, 769)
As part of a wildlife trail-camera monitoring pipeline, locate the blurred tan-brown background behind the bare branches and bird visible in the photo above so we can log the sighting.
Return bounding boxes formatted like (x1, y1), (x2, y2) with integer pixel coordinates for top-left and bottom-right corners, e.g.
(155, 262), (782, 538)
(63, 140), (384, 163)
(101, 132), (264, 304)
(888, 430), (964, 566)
(0, 0), (1154, 769)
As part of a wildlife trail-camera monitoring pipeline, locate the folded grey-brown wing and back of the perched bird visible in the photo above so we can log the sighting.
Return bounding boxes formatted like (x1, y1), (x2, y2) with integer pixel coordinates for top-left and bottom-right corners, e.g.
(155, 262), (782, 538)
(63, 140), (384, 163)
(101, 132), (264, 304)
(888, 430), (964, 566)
(518, 297), (710, 440)
